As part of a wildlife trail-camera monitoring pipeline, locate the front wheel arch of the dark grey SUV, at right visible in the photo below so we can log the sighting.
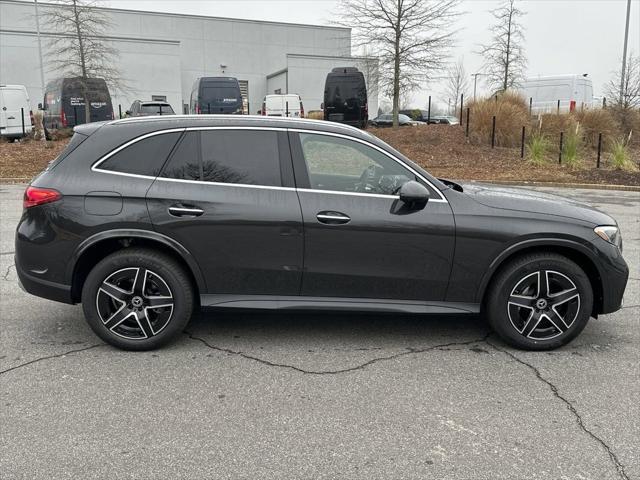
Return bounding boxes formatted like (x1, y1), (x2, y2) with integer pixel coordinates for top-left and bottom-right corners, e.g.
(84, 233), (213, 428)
(478, 241), (603, 316)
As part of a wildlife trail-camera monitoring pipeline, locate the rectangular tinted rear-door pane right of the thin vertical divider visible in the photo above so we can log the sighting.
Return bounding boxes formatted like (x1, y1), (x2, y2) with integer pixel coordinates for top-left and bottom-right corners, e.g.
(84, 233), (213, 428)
(200, 130), (282, 186)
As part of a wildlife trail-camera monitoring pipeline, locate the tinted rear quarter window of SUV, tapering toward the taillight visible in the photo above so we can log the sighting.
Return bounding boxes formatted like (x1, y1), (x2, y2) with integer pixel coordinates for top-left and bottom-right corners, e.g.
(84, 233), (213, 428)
(99, 132), (180, 177)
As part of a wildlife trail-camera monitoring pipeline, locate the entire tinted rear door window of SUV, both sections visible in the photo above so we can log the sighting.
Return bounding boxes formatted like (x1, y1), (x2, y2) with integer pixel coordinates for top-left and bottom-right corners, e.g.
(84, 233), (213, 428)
(161, 129), (282, 186)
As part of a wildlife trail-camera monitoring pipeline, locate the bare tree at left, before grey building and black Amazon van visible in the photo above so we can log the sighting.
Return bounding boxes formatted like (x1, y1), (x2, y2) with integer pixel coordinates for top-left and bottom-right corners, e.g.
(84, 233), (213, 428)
(42, 0), (126, 121)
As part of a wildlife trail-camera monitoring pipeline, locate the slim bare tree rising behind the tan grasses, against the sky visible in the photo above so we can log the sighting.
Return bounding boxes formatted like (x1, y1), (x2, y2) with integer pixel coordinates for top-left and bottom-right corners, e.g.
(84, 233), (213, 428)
(478, 0), (527, 91)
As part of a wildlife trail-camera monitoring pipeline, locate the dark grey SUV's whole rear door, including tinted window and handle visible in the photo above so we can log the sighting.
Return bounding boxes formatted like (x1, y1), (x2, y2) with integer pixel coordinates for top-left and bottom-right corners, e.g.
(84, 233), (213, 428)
(147, 128), (303, 295)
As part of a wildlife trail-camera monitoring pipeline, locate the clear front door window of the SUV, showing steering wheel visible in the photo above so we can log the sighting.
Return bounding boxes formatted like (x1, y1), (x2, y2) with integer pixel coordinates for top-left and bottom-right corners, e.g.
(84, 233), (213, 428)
(300, 133), (416, 195)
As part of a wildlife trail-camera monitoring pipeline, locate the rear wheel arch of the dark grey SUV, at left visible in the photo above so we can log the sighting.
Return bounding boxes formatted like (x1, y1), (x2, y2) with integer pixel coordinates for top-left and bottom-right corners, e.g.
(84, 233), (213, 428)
(68, 231), (206, 303)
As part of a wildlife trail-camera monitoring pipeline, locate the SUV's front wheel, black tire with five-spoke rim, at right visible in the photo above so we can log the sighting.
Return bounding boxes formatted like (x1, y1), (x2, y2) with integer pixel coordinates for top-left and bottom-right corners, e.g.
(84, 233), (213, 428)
(486, 253), (593, 350)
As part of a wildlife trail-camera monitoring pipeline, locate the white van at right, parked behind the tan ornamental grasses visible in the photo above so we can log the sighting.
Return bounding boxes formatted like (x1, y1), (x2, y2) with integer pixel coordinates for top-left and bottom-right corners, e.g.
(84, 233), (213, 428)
(521, 74), (595, 114)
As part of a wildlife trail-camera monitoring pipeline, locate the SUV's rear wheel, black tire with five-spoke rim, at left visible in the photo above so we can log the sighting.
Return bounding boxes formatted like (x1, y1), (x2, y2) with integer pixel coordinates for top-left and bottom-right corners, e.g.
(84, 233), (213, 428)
(82, 248), (194, 350)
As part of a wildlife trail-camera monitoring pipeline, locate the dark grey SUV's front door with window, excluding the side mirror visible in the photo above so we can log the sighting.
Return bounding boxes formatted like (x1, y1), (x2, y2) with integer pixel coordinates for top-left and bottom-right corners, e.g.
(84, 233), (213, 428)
(290, 132), (455, 301)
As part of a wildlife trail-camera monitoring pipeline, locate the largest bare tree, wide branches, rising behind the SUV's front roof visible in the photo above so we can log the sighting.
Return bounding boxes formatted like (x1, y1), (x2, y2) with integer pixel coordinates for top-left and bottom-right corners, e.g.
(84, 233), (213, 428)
(336, 0), (460, 127)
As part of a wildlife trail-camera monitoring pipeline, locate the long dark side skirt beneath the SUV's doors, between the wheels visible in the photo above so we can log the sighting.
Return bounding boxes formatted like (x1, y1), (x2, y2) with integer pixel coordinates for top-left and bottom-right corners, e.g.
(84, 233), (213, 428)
(200, 294), (480, 314)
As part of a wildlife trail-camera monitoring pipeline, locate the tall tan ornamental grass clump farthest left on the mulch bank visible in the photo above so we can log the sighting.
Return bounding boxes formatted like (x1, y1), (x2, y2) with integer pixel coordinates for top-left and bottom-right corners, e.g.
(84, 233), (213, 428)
(468, 92), (530, 147)
